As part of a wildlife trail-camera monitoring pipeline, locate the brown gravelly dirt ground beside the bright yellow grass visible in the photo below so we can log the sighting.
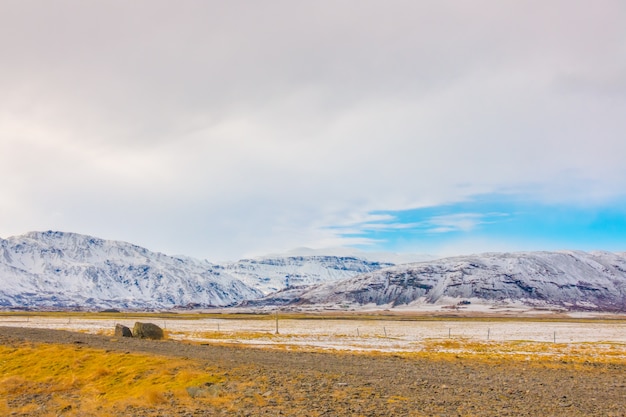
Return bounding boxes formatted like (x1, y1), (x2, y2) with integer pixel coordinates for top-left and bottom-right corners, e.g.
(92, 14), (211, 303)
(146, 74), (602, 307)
(0, 327), (626, 417)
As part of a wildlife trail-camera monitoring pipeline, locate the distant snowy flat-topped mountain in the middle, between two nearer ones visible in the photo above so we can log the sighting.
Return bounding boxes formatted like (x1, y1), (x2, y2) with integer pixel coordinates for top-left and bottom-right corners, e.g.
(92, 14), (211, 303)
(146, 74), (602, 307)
(224, 255), (393, 294)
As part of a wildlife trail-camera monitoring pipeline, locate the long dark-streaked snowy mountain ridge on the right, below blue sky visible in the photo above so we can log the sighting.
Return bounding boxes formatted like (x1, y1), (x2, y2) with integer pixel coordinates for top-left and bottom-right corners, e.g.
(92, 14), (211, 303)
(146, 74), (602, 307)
(247, 251), (626, 311)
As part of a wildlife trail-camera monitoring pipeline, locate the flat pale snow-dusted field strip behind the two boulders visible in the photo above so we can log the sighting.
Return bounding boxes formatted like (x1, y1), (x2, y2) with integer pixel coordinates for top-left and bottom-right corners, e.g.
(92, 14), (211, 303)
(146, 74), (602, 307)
(0, 315), (626, 351)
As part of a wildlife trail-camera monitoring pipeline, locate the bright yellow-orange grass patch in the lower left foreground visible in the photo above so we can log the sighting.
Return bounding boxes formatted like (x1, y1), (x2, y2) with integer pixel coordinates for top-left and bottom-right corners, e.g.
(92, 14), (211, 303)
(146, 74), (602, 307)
(0, 345), (232, 416)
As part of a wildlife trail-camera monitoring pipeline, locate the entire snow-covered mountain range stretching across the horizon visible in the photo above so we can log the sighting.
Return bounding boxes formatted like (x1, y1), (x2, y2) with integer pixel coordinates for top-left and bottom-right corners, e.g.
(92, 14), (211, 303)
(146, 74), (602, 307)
(0, 232), (626, 311)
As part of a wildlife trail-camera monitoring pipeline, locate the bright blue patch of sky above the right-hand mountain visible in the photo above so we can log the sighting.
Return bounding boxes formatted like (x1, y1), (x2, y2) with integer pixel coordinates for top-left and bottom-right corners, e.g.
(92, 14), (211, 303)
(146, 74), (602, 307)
(337, 195), (626, 253)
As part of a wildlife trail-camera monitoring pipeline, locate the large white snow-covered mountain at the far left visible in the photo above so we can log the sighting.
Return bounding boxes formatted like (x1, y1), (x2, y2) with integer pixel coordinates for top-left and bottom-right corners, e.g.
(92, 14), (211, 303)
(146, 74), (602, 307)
(0, 231), (262, 309)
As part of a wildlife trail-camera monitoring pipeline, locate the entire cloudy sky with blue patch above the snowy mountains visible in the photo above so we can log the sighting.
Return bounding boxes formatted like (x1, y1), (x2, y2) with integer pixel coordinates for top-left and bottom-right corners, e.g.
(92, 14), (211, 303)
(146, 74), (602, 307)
(0, 0), (626, 261)
